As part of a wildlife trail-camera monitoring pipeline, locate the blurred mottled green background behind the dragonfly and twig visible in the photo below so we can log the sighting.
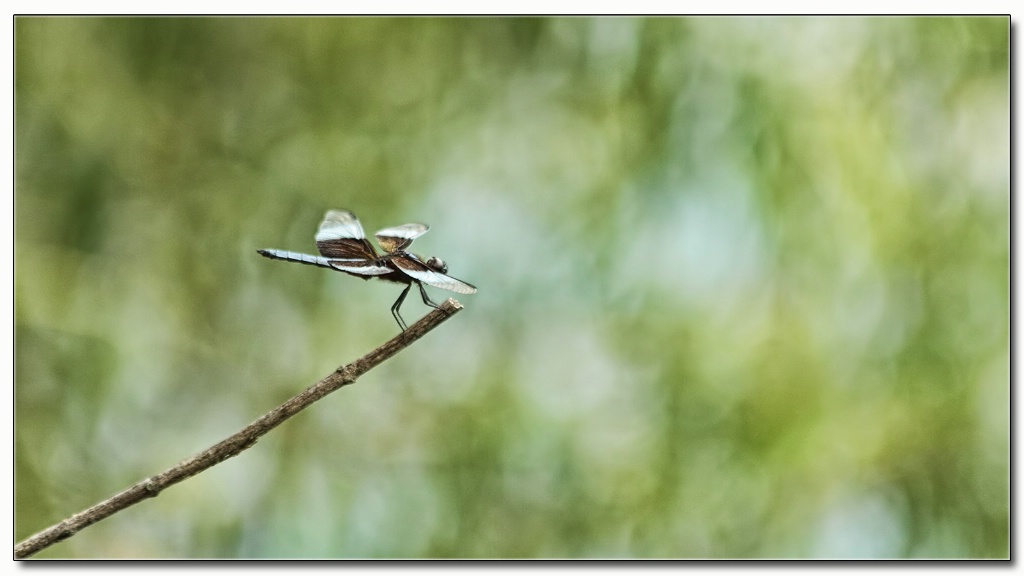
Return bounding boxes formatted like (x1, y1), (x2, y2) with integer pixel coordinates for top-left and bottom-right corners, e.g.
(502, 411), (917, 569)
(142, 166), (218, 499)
(15, 17), (1010, 559)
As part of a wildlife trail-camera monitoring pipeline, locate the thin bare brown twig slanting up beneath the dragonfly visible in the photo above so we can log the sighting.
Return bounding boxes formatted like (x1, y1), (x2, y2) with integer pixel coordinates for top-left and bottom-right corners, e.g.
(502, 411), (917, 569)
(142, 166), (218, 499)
(14, 298), (462, 559)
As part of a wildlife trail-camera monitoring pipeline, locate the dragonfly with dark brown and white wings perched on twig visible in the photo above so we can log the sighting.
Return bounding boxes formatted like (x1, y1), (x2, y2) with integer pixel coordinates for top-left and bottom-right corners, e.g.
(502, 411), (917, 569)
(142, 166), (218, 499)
(256, 210), (476, 332)
